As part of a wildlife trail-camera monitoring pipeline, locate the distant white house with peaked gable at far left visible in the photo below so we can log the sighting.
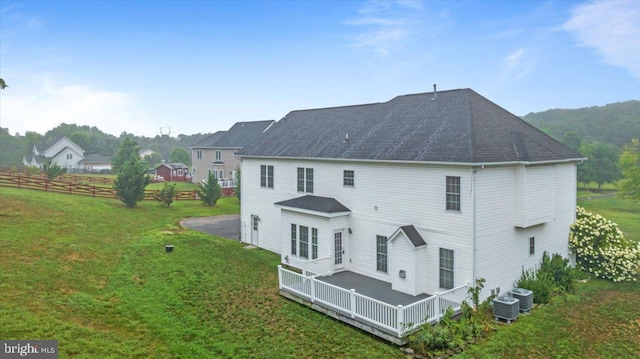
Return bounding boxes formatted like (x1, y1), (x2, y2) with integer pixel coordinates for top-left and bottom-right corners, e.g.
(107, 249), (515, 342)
(22, 137), (84, 169)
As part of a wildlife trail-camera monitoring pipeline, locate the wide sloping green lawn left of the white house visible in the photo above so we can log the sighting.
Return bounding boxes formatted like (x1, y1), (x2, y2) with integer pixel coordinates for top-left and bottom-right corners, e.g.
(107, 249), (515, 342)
(0, 188), (403, 358)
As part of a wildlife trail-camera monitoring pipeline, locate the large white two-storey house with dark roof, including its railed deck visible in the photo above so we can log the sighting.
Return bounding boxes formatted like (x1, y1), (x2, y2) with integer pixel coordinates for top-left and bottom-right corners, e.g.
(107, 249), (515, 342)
(239, 86), (581, 342)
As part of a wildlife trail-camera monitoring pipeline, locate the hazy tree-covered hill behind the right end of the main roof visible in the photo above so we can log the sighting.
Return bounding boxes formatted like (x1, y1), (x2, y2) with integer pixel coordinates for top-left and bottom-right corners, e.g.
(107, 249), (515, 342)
(523, 100), (640, 148)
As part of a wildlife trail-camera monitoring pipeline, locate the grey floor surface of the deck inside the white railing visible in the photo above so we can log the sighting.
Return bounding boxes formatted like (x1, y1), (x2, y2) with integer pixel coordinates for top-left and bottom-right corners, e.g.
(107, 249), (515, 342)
(316, 271), (431, 306)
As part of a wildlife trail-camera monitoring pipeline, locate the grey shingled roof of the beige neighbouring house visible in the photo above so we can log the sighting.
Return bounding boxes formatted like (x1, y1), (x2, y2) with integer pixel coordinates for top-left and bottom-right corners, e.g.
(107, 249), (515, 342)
(188, 120), (275, 148)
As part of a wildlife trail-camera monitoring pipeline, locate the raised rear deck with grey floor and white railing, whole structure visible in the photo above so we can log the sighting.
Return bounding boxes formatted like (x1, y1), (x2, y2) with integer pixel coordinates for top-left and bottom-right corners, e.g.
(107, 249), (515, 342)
(278, 266), (468, 345)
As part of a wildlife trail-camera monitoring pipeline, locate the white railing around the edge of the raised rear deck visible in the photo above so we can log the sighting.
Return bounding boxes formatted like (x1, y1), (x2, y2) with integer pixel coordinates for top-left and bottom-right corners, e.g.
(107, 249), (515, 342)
(278, 265), (469, 338)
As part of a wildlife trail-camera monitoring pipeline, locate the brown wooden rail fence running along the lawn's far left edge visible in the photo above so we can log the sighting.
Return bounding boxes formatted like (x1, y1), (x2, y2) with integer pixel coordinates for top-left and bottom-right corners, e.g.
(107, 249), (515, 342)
(0, 172), (234, 201)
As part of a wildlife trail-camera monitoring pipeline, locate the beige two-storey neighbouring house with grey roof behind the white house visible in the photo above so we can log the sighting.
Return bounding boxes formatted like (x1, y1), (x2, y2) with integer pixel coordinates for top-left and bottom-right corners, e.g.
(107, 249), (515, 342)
(191, 120), (275, 182)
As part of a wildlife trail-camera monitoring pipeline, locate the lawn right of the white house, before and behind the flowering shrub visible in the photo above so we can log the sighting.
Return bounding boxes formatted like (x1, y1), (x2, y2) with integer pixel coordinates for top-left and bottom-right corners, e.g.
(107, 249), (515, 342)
(456, 197), (640, 358)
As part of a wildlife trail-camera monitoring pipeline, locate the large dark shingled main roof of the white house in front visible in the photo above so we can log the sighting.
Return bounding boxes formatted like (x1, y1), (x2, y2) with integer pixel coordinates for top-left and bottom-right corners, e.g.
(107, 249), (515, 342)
(238, 89), (581, 163)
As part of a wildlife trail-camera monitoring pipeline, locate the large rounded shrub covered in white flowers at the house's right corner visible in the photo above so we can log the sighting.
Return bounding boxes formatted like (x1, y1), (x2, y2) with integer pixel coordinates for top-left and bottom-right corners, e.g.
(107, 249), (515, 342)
(569, 207), (640, 282)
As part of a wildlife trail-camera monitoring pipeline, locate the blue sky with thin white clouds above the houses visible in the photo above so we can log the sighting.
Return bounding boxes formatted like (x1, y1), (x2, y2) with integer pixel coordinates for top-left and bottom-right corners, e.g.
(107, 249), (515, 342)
(0, 0), (640, 136)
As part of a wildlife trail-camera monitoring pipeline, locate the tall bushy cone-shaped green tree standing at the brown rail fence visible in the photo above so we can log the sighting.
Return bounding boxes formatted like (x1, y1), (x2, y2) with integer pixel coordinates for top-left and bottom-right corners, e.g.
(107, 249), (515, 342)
(113, 151), (151, 208)
